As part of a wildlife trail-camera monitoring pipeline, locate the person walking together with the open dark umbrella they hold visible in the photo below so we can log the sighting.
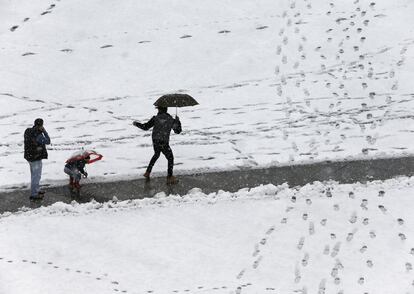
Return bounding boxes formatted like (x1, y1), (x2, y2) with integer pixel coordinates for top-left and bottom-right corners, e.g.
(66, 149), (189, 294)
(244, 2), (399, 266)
(132, 94), (198, 185)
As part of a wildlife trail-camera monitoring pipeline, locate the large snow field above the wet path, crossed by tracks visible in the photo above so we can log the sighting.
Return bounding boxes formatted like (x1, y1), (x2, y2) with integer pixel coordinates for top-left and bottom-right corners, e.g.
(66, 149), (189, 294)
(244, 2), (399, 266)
(0, 0), (414, 187)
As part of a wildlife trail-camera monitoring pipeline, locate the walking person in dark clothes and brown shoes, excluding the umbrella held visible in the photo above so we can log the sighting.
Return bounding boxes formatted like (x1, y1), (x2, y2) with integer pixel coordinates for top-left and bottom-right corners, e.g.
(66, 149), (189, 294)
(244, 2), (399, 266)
(133, 106), (181, 184)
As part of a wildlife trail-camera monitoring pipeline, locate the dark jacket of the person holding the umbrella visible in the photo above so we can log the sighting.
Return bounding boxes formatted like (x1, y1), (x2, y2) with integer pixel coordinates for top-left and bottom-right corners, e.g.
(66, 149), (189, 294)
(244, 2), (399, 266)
(135, 112), (181, 144)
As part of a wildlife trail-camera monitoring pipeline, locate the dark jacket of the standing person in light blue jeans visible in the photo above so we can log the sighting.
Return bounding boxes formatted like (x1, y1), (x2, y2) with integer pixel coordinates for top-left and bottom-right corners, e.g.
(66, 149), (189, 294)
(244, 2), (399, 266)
(24, 127), (50, 161)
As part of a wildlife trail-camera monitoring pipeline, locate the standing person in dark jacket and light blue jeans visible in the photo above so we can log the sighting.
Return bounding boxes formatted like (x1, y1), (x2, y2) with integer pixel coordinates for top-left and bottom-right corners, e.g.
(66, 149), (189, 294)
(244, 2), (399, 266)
(24, 118), (50, 200)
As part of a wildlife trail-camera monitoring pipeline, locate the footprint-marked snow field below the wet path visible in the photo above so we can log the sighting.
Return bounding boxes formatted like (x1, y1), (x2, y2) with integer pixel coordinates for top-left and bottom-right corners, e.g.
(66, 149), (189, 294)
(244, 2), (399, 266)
(0, 177), (414, 294)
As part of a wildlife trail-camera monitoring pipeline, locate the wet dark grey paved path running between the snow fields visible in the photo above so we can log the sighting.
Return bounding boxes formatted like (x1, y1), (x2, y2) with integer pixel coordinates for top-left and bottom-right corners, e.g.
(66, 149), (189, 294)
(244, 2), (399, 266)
(0, 157), (414, 213)
